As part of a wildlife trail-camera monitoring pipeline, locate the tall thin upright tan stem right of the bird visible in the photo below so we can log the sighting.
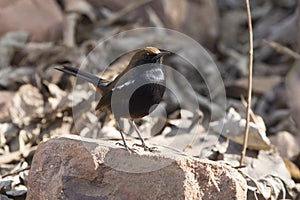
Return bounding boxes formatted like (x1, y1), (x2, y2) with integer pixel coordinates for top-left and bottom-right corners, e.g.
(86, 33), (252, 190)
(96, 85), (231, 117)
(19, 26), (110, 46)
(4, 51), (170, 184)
(240, 0), (253, 166)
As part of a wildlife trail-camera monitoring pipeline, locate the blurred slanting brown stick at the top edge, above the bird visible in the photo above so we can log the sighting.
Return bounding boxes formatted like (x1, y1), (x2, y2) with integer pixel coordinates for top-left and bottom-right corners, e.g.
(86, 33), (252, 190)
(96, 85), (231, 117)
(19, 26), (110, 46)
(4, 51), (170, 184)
(97, 0), (152, 26)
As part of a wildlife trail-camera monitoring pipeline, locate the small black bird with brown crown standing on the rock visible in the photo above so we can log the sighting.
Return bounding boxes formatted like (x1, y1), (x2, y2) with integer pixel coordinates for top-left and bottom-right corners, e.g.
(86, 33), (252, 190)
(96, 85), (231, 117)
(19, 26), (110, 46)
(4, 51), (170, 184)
(55, 46), (170, 152)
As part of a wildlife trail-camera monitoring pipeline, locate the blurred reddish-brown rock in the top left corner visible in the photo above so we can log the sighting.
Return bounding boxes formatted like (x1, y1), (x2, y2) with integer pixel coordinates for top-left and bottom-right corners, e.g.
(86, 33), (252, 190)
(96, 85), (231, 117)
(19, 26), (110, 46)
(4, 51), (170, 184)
(0, 0), (63, 42)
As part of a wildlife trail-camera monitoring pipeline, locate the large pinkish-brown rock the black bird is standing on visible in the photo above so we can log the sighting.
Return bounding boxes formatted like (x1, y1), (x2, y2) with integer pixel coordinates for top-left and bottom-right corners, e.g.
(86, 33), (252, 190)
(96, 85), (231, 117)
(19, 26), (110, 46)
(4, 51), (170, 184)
(27, 136), (247, 200)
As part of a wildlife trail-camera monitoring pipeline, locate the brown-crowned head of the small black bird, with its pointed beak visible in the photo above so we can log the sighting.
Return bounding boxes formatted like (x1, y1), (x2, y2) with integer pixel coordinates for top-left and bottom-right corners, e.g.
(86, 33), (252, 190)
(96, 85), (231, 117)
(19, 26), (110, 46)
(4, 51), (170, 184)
(130, 47), (170, 66)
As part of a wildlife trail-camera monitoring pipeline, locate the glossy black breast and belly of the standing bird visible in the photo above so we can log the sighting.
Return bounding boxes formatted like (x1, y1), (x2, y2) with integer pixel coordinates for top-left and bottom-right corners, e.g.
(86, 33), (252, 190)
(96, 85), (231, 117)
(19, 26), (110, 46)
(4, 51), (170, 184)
(108, 65), (165, 118)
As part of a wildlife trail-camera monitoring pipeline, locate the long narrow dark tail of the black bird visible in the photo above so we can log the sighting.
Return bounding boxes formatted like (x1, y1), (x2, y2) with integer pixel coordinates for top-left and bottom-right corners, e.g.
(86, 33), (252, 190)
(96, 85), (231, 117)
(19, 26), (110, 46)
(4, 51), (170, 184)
(55, 66), (109, 94)
